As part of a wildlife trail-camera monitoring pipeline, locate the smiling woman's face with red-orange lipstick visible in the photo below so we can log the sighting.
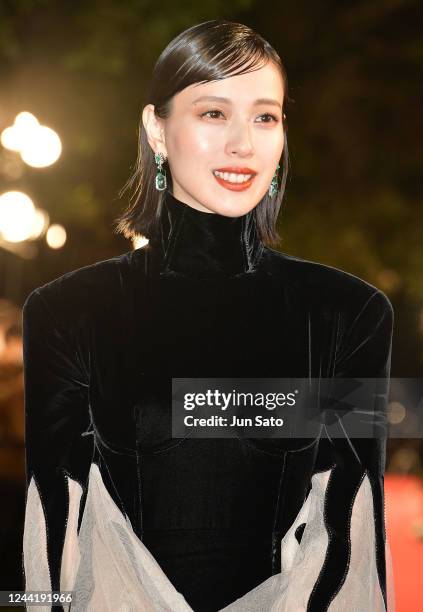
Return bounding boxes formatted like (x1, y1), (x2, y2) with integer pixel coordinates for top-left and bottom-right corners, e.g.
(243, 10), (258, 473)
(148, 62), (284, 217)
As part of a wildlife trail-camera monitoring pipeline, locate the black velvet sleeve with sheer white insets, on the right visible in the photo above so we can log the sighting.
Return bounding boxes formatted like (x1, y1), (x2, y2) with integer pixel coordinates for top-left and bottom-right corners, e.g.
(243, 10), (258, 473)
(301, 291), (394, 612)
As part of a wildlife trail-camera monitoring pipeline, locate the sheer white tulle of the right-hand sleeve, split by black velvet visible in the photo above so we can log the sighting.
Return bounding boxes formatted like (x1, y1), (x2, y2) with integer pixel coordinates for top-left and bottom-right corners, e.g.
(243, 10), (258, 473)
(221, 470), (395, 612)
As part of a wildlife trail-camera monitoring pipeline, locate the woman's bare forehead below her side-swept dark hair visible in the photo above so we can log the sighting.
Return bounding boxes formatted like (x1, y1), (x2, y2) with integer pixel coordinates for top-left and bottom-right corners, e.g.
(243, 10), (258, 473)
(174, 62), (284, 106)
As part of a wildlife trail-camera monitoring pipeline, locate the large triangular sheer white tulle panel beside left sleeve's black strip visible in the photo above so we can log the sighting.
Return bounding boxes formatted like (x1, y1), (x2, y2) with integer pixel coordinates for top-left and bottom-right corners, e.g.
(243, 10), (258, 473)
(72, 463), (191, 612)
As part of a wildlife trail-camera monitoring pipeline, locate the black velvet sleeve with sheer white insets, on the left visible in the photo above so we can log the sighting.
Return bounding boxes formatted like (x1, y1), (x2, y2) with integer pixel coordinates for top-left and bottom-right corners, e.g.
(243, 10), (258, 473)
(23, 289), (93, 611)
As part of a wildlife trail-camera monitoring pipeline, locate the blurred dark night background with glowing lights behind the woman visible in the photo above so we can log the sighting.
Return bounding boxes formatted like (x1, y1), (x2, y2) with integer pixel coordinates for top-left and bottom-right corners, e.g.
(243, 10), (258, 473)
(0, 0), (423, 612)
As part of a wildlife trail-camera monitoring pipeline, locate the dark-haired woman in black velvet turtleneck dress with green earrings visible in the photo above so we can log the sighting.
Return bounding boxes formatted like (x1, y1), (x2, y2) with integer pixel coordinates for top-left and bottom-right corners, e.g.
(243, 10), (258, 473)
(24, 21), (393, 612)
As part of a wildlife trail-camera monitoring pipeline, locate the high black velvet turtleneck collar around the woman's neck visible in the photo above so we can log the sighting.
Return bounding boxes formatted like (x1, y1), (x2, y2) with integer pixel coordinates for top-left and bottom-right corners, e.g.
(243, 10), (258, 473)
(149, 191), (263, 278)
